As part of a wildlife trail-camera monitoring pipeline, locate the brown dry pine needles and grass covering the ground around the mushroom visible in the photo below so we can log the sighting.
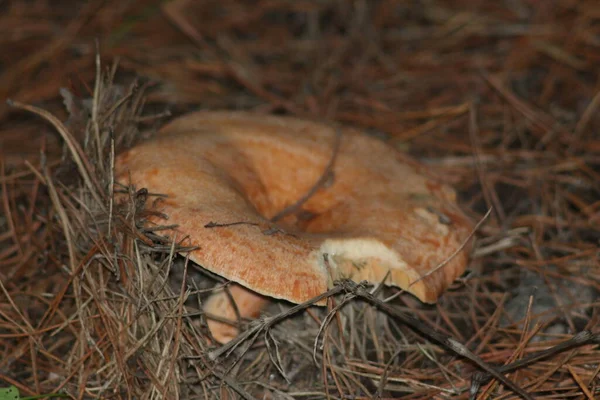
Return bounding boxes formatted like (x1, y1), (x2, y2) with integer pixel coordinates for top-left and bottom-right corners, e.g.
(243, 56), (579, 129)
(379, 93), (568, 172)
(0, 0), (600, 399)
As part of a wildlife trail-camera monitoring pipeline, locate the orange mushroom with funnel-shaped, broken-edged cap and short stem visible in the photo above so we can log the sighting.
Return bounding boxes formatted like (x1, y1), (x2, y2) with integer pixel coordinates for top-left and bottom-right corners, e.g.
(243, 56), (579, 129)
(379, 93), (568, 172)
(116, 112), (473, 343)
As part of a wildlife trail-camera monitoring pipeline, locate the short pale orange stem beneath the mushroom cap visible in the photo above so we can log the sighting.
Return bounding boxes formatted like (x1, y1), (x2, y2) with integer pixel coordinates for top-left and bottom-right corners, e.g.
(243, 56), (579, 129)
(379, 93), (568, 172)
(204, 283), (269, 344)
